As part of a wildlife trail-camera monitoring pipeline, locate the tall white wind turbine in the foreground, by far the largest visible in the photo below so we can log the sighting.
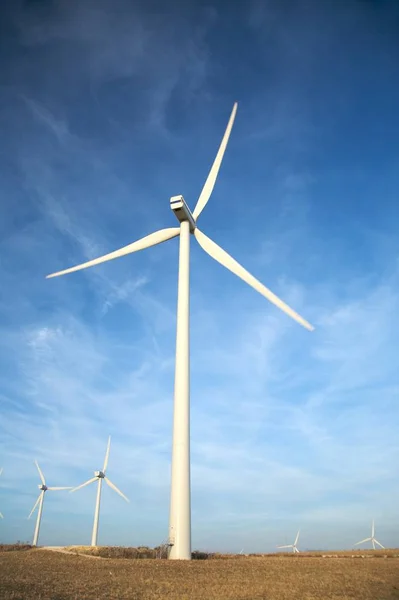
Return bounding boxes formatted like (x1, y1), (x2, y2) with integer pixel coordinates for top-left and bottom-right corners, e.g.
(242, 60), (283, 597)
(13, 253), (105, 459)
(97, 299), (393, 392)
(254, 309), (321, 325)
(47, 103), (313, 560)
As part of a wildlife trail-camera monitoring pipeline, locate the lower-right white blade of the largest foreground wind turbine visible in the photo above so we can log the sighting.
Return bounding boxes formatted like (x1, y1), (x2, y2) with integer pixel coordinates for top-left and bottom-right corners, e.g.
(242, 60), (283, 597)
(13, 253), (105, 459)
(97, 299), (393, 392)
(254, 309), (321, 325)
(194, 228), (314, 331)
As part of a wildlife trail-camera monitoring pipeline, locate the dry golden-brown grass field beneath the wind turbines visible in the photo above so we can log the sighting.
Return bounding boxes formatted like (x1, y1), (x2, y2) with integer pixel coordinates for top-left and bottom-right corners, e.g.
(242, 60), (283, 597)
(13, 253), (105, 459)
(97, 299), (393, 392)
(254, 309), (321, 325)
(0, 546), (399, 600)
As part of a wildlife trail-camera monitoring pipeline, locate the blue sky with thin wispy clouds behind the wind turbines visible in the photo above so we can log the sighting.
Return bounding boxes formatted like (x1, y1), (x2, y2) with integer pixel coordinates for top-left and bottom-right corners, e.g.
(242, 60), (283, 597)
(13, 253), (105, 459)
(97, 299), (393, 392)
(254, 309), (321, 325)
(0, 0), (399, 552)
